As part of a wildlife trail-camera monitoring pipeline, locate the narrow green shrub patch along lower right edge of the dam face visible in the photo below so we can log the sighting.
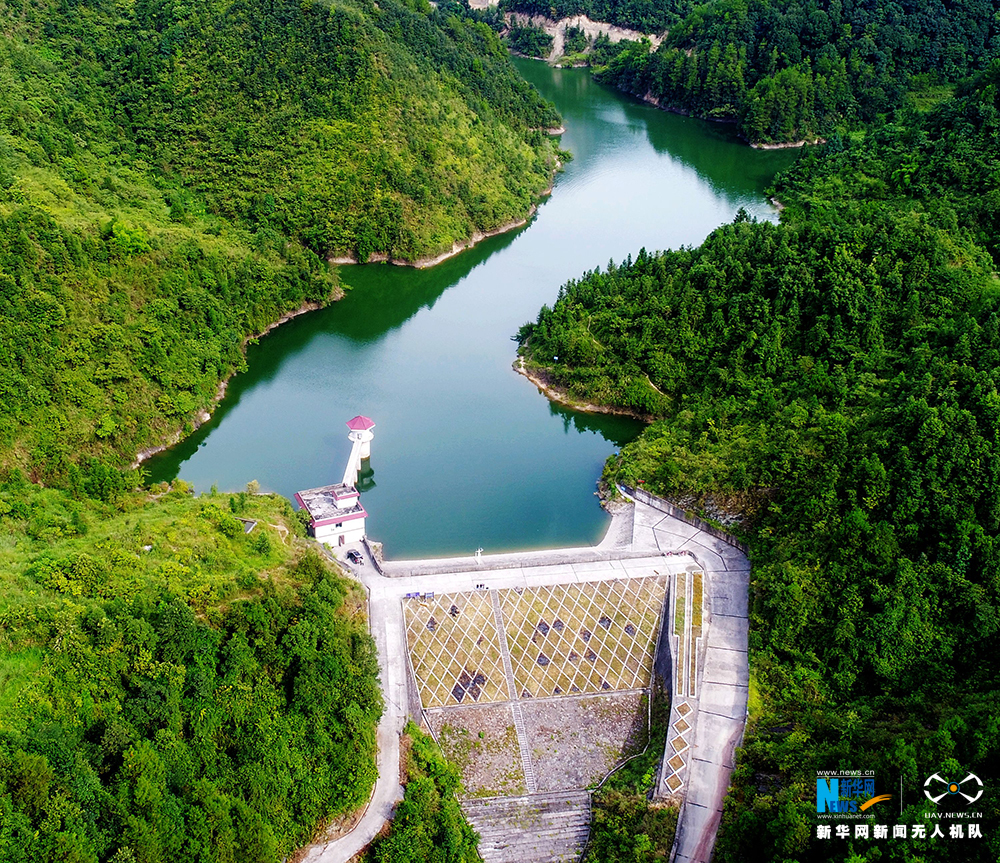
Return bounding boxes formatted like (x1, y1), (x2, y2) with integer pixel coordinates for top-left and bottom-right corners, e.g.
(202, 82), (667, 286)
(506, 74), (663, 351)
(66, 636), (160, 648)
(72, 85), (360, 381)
(585, 681), (677, 863)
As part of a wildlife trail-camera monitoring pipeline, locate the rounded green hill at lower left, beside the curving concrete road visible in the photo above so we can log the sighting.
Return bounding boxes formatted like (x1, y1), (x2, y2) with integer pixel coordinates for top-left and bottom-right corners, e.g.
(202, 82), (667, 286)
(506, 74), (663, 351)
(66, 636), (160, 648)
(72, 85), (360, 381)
(0, 480), (381, 863)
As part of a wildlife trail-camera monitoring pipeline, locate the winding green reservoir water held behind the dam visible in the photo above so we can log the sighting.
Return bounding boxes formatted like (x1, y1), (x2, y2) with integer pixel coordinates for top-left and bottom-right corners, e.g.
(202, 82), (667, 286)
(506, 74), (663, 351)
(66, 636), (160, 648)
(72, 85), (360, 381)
(147, 61), (795, 557)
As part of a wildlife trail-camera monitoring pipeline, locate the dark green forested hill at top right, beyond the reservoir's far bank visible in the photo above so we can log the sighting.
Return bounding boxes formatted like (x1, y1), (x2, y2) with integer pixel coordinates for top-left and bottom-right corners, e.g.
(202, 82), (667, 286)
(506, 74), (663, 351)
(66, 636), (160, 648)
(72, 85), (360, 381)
(601, 0), (1000, 142)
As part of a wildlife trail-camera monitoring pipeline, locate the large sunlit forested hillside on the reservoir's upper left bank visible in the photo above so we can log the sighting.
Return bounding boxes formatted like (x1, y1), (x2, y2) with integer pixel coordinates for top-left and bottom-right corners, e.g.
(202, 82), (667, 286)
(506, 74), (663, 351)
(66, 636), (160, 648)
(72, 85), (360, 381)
(0, 0), (559, 481)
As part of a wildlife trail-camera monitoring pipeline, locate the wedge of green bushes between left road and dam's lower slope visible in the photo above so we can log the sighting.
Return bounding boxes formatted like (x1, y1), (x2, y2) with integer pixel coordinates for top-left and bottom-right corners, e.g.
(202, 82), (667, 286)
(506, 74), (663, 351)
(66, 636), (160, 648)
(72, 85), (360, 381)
(368, 722), (480, 863)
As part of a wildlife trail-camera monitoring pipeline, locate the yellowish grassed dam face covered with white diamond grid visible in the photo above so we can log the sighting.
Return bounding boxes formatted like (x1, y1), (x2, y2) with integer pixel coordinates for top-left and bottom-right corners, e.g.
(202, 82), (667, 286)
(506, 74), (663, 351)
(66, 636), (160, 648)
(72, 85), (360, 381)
(403, 576), (667, 709)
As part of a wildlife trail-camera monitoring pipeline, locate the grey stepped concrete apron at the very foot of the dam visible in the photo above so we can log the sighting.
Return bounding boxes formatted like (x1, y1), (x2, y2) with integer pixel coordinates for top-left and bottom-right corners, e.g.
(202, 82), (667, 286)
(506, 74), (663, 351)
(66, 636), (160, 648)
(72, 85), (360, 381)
(462, 791), (590, 863)
